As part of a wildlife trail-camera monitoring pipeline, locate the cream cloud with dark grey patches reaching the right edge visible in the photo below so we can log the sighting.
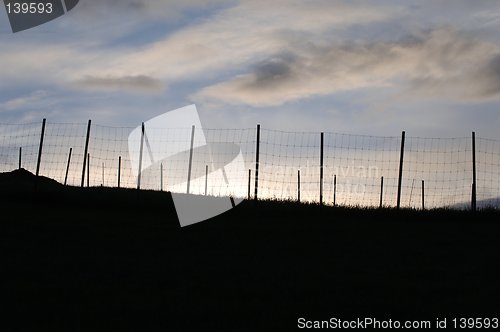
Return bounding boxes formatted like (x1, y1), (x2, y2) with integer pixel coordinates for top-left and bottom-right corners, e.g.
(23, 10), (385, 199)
(193, 28), (500, 106)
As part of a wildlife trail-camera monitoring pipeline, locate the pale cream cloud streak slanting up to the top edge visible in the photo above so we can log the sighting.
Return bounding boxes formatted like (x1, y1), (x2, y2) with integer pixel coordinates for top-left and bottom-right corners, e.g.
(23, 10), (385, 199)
(64, 0), (391, 82)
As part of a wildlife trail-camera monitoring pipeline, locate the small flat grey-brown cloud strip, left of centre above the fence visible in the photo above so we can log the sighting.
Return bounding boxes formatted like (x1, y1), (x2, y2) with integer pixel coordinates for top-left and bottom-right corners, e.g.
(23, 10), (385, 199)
(76, 75), (165, 92)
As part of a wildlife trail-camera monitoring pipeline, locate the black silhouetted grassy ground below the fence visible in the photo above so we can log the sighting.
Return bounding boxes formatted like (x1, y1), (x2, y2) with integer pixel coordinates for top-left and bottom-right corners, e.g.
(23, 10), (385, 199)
(0, 173), (500, 331)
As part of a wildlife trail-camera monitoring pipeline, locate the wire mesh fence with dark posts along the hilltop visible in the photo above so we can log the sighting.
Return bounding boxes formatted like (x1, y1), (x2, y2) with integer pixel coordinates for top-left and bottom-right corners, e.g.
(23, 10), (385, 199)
(0, 120), (500, 208)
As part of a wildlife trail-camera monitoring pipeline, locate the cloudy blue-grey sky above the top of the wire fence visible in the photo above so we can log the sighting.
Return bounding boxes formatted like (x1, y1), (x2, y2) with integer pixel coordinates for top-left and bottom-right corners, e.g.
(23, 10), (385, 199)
(0, 0), (500, 138)
